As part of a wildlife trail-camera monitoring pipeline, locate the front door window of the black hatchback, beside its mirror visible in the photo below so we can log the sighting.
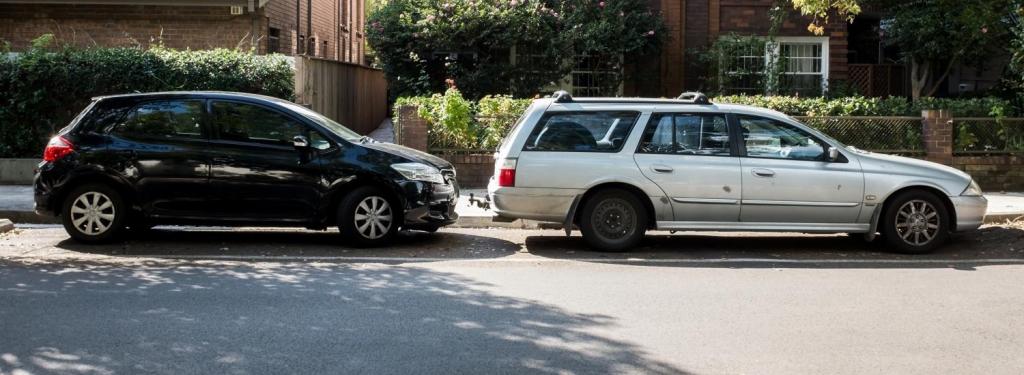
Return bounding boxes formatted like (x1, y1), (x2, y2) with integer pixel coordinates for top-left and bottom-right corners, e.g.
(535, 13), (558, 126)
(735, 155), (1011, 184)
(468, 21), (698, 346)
(210, 100), (306, 147)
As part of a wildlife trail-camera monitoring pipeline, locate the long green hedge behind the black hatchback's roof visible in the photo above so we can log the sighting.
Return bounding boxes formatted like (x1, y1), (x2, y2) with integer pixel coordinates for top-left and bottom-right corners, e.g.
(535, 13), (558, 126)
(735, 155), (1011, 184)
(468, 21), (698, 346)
(0, 43), (294, 158)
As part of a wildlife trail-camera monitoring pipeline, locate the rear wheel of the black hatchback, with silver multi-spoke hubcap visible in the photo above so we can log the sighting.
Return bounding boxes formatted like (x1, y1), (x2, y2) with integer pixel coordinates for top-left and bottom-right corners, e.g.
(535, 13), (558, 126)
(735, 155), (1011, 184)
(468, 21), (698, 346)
(60, 183), (131, 244)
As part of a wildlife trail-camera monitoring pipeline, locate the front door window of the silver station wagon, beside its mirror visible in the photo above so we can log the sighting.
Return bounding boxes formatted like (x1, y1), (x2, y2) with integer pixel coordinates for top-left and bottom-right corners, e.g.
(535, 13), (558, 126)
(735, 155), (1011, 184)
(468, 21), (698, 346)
(737, 115), (825, 161)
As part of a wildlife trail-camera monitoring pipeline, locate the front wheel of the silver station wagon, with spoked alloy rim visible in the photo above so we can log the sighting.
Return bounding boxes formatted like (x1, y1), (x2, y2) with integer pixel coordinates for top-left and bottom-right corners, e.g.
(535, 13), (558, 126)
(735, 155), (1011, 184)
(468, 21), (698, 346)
(880, 191), (949, 254)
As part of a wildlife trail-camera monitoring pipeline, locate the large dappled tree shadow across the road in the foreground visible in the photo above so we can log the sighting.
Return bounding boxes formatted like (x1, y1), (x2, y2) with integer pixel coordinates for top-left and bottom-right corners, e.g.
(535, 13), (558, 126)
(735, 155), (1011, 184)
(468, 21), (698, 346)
(0, 260), (685, 374)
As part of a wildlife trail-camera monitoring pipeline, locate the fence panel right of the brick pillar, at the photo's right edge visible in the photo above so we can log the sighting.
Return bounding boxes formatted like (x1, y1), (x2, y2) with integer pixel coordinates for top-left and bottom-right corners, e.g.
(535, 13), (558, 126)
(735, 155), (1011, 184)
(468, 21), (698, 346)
(952, 117), (1024, 155)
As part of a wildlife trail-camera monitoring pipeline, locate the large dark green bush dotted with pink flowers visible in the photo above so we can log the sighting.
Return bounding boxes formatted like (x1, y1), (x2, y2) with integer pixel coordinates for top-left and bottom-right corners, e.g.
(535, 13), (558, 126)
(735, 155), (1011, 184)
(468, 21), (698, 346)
(367, 0), (666, 98)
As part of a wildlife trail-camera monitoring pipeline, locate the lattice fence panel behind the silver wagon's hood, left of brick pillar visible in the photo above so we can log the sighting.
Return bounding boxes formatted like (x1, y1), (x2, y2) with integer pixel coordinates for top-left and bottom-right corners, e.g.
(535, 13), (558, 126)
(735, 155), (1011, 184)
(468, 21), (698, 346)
(796, 116), (925, 155)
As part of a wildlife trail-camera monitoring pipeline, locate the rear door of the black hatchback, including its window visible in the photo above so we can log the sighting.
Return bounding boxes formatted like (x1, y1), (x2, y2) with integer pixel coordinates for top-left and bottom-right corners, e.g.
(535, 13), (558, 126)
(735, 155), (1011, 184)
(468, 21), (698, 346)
(106, 99), (212, 217)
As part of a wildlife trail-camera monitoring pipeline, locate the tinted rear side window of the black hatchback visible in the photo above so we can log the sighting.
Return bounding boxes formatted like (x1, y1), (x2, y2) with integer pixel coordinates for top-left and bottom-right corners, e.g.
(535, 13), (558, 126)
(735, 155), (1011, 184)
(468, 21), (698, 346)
(113, 100), (204, 139)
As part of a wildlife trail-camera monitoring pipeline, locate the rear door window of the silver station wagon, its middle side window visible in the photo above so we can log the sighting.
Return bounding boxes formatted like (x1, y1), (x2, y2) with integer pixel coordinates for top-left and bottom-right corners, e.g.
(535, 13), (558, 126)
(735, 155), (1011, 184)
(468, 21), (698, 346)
(637, 114), (731, 156)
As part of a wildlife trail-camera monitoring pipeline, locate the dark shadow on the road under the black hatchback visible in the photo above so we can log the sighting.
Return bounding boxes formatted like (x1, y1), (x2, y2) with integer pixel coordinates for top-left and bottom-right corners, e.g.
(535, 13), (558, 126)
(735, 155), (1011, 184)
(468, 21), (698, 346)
(57, 227), (520, 259)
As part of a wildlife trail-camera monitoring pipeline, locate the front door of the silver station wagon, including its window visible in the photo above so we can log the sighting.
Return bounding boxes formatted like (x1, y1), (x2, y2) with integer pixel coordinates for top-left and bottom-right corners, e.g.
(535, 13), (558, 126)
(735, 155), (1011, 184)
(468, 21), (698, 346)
(736, 115), (864, 223)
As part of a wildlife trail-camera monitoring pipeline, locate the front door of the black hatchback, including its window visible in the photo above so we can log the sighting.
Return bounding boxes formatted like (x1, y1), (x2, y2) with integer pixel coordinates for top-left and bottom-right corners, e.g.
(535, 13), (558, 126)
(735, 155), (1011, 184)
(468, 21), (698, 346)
(209, 99), (323, 221)
